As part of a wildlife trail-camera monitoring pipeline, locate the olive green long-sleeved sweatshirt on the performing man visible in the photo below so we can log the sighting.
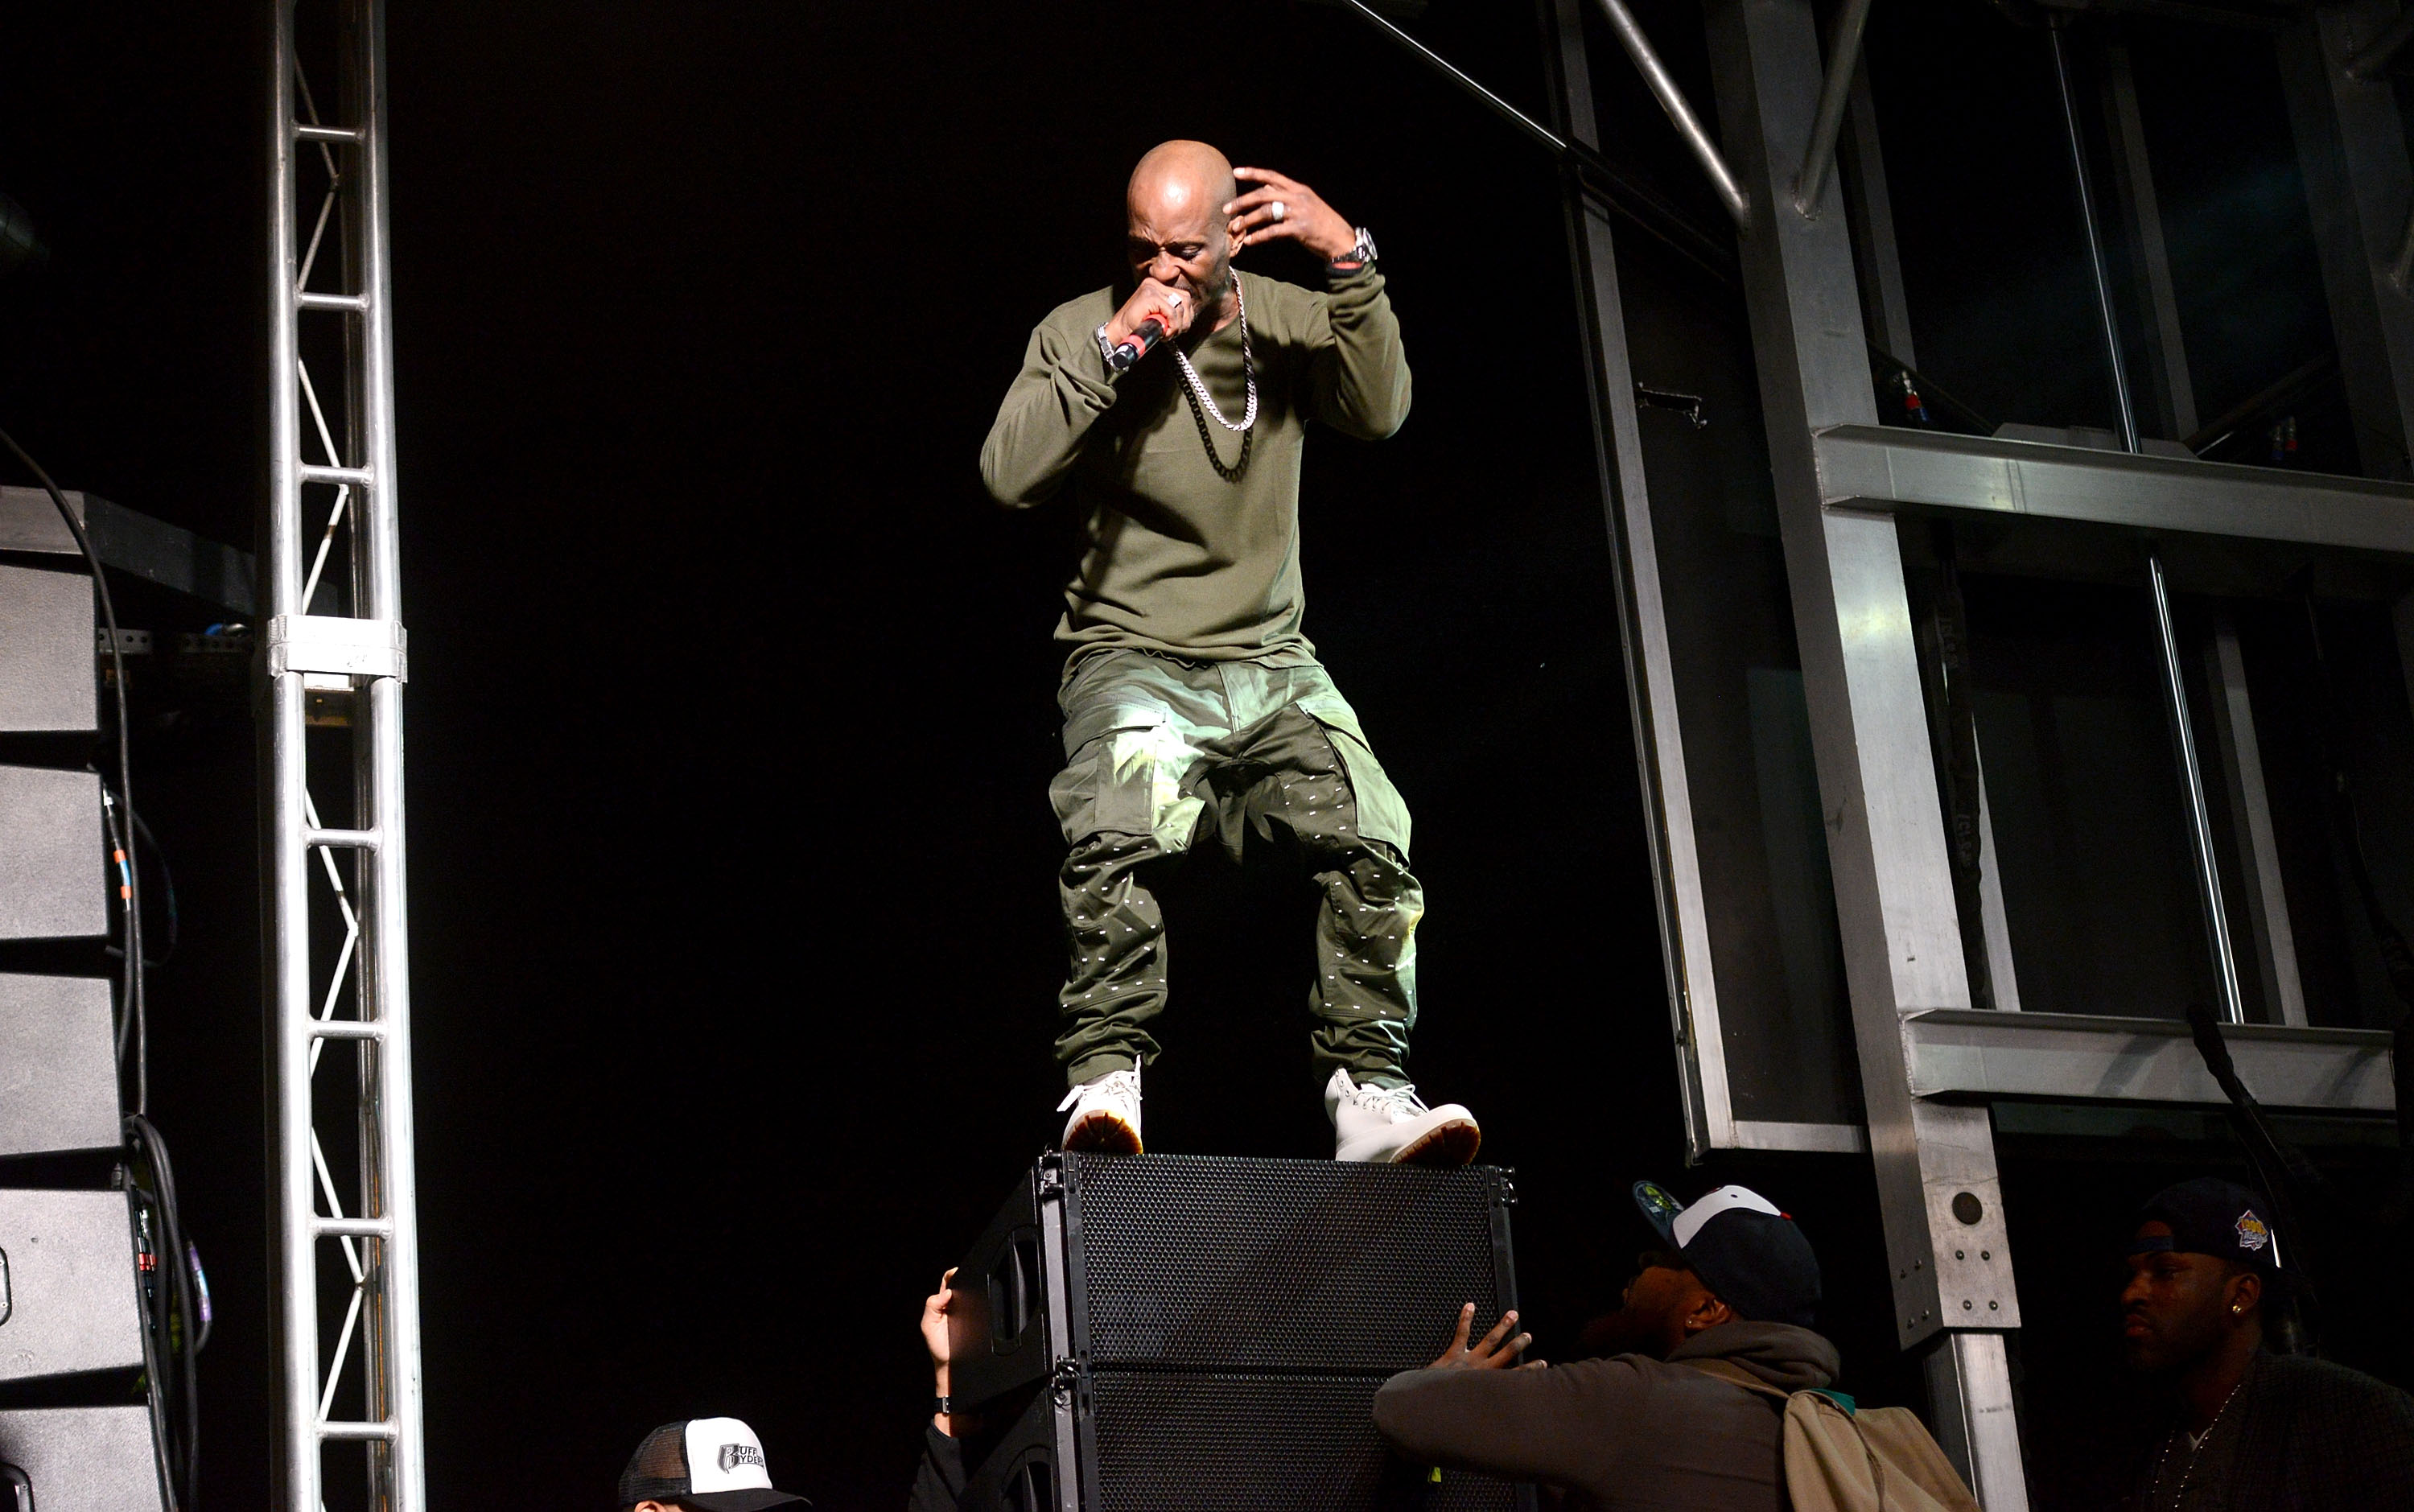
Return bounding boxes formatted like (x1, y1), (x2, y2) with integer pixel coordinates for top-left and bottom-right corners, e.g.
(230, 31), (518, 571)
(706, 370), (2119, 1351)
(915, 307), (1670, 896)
(980, 268), (1407, 661)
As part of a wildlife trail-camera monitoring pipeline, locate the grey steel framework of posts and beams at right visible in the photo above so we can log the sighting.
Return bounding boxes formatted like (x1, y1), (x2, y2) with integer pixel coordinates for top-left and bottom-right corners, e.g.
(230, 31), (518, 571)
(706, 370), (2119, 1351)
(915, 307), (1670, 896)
(1543, 0), (2414, 1512)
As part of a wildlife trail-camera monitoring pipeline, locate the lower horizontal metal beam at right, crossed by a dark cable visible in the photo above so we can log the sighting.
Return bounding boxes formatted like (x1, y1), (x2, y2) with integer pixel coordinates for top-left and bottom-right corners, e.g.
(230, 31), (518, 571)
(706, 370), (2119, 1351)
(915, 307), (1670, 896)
(1902, 1012), (2397, 1114)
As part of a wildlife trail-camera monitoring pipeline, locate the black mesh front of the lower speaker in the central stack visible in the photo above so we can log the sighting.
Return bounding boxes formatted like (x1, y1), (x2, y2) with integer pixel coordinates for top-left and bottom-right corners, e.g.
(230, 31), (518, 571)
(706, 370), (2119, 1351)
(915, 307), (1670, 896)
(1091, 1372), (1516, 1512)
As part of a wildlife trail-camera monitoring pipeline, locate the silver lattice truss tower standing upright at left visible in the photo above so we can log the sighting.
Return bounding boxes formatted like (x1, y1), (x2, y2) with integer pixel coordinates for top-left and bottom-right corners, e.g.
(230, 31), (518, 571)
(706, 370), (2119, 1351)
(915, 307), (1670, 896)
(263, 0), (427, 1512)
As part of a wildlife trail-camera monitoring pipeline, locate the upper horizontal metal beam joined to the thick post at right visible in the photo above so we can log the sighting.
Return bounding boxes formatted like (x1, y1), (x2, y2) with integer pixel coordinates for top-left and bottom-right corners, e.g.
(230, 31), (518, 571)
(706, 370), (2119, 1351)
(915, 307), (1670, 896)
(1815, 425), (2414, 555)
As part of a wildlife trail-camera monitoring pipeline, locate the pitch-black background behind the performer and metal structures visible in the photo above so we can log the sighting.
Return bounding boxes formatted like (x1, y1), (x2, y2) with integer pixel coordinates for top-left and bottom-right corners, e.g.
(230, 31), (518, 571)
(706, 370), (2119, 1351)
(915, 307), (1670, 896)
(0, 0), (2402, 1507)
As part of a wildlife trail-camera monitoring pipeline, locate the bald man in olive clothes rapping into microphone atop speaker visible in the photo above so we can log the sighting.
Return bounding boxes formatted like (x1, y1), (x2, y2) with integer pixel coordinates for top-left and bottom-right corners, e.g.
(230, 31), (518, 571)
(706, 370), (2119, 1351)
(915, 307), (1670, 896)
(980, 142), (1482, 1164)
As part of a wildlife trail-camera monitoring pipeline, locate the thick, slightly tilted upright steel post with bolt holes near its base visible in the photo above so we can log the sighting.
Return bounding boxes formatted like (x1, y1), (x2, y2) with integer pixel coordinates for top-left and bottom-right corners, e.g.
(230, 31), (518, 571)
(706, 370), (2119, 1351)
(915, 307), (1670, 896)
(1709, 0), (2028, 1487)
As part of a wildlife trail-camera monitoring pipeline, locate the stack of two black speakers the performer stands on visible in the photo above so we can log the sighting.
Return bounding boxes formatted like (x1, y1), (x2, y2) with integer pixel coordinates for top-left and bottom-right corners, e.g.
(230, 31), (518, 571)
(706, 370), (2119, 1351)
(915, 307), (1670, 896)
(949, 1155), (1533, 1512)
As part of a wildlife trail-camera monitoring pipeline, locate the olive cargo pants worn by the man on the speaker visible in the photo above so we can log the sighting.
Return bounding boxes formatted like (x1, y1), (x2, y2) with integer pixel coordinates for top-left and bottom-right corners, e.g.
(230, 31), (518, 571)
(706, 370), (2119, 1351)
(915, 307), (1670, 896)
(1048, 649), (1424, 1087)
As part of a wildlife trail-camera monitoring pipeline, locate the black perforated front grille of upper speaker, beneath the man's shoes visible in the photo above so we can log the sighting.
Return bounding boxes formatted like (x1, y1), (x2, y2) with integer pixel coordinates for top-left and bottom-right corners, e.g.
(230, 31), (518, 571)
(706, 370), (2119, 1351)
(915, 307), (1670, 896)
(1065, 1155), (1514, 1374)
